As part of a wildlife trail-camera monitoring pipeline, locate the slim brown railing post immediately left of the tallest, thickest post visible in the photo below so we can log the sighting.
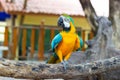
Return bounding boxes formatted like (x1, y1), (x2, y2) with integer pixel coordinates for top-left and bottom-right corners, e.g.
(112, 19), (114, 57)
(30, 29), (35, 59)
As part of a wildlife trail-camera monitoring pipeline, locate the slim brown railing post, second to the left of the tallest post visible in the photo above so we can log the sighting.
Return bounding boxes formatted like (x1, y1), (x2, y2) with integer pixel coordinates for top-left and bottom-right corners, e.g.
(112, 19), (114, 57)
(22, 29), (27, 58)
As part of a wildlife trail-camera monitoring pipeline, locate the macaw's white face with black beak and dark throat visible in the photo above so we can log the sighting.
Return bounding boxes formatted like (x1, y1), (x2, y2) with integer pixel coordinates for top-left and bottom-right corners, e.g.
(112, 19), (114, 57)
(57, 15), (70, 31)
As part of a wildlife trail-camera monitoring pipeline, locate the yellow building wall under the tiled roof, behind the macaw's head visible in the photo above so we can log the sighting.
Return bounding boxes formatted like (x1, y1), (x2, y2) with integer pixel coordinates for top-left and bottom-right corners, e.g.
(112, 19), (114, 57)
(16, 15), (90, 29)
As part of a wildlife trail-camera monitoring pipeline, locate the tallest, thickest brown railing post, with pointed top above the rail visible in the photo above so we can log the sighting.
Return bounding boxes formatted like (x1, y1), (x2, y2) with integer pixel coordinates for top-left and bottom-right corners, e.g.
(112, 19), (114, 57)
(38, 22), (45, 60)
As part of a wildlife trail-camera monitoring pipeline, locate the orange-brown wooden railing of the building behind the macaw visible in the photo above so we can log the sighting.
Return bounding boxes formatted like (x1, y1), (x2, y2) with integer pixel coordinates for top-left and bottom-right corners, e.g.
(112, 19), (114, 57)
(3, 23), (93, 60)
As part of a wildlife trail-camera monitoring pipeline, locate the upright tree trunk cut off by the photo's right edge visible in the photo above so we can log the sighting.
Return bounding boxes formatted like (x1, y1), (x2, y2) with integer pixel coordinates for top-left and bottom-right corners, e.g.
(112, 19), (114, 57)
(109, 0), (120, 49)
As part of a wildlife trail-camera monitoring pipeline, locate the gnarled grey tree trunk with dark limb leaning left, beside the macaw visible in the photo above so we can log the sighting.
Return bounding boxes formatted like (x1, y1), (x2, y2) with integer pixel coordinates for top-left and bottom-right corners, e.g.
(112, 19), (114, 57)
(79, 0), (120, 62)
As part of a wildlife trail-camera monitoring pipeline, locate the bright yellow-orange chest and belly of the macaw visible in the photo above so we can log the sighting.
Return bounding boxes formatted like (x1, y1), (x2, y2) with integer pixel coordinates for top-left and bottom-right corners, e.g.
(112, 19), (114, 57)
(56, 32), (76, 56)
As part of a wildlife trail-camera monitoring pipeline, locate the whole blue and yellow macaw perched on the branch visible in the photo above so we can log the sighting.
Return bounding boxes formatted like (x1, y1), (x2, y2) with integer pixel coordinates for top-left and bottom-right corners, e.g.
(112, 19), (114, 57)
(47, 15), (83, 67)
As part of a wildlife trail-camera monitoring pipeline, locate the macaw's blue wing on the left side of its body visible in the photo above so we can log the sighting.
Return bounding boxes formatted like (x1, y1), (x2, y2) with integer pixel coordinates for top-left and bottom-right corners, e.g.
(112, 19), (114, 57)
(51, 34), (62, 50)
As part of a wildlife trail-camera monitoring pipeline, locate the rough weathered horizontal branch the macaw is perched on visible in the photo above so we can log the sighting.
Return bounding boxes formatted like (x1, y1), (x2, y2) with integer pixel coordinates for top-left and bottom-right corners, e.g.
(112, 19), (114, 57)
(0, 56), (120, 80)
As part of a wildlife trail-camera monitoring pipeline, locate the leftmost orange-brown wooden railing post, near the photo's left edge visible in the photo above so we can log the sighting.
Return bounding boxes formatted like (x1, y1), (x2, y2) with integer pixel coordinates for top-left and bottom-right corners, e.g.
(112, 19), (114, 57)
(3, 26), (9, 58)
